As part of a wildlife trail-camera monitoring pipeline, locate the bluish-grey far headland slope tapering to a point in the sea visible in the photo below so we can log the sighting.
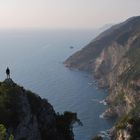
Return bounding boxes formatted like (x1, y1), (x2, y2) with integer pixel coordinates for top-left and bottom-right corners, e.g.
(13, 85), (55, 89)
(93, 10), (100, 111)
(65, 17), (140, 71)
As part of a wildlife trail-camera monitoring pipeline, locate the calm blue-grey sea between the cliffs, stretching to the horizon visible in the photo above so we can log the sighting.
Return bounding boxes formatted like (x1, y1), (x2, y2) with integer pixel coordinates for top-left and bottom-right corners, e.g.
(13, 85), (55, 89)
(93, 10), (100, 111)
(0, 29), (114, 140)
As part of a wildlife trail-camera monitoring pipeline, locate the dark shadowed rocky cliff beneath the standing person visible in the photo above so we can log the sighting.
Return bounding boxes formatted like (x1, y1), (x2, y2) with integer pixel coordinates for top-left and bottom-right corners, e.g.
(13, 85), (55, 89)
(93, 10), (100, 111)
(0, 79), (78, 140)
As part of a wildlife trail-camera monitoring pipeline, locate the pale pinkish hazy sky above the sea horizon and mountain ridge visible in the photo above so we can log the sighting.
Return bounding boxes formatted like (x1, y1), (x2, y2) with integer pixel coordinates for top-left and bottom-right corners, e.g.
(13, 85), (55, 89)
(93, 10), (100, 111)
(0, 0), (140, 29)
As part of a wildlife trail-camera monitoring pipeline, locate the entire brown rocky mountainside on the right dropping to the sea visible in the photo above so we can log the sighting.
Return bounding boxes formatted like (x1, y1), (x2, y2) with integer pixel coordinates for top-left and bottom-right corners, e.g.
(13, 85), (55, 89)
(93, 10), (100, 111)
(65, 16), (140, 140)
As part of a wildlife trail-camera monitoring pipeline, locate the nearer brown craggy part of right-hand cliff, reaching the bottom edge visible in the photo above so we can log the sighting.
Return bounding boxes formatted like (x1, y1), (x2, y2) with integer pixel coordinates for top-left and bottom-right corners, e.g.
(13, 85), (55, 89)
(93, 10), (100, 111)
(105, 35), (140, 140)
